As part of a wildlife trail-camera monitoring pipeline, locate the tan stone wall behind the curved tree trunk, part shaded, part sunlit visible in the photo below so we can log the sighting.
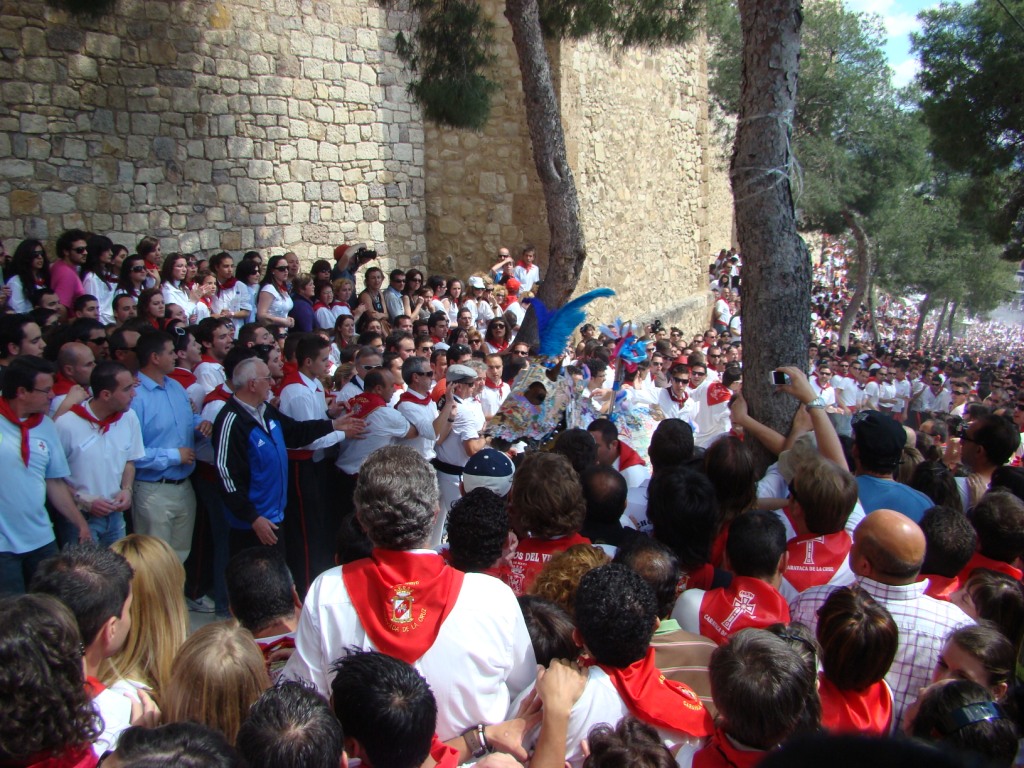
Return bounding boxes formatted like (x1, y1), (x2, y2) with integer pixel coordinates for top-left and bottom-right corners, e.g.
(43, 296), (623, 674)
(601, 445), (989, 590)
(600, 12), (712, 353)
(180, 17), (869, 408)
(426, 6), (732, 330)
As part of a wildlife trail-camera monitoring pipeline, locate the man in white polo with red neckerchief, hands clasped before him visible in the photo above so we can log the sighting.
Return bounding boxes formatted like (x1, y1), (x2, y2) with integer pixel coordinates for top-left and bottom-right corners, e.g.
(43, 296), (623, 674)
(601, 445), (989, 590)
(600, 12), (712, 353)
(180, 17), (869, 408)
(55, 361), (145, 547)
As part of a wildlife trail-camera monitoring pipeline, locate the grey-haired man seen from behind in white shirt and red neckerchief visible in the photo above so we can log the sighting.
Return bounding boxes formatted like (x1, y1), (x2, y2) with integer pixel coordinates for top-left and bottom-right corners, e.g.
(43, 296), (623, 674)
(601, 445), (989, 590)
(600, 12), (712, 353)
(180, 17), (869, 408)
(284, 445), (536, 754)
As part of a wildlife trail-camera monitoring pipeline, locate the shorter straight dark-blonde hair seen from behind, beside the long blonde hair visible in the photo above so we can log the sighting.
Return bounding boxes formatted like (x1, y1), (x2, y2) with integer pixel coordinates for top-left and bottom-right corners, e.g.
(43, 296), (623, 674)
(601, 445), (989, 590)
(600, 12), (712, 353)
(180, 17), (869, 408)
(163, 621), (270, 744)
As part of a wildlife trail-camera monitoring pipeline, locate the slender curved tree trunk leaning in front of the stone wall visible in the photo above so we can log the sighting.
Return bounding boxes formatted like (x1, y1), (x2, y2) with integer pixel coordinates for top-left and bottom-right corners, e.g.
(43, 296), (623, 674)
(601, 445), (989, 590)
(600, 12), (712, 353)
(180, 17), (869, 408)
(505, 0), (587, 309)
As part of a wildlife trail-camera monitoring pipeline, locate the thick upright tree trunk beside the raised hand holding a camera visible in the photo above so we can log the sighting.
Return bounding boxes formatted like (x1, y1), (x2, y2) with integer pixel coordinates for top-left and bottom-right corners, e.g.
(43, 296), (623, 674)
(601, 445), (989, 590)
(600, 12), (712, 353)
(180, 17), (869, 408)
(730, 0), (811, 459)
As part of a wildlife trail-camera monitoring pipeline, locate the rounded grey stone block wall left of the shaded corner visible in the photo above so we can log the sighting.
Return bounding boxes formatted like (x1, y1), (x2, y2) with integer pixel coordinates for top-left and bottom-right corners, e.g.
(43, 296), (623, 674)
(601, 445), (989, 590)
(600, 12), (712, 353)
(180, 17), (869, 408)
(0, 0), (426, 263)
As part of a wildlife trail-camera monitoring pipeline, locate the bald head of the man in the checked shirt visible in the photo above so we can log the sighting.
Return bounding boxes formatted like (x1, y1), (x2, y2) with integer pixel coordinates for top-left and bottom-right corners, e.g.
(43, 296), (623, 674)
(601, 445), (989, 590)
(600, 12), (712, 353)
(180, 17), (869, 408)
(850, 509), (926, 585)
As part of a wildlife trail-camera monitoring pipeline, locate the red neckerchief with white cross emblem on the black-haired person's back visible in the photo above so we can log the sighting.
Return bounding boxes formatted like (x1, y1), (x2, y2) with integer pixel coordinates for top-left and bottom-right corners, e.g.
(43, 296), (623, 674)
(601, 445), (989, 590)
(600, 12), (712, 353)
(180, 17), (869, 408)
(699, 575), (790, 645)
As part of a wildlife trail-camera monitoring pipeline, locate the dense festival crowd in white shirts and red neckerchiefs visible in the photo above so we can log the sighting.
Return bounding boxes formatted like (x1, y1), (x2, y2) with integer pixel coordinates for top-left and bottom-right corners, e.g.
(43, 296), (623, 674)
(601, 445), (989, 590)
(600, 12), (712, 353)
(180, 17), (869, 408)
(0, 230), (1024, 768)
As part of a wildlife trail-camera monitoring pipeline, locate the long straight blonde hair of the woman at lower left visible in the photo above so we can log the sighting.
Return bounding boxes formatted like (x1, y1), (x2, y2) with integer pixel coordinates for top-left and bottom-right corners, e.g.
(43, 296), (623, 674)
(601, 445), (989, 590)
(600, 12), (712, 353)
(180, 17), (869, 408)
(99, 534), (188, 702)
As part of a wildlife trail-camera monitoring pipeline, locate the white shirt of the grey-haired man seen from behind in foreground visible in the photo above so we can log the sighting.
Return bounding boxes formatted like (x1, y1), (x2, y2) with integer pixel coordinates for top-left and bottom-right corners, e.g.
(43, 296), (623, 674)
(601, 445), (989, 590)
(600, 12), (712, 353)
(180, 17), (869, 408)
(283, 557), (537, 740)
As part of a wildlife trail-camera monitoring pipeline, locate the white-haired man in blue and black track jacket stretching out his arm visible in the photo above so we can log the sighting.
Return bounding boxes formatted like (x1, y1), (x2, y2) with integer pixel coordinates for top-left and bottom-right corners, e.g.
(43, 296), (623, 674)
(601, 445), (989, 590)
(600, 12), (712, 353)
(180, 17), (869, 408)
(213, 357), (364, 572)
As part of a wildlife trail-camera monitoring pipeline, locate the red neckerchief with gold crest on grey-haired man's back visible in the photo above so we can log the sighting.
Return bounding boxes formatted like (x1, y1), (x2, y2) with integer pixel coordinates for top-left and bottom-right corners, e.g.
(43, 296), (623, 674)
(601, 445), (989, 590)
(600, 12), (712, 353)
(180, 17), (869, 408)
(341, 549), (464, 664)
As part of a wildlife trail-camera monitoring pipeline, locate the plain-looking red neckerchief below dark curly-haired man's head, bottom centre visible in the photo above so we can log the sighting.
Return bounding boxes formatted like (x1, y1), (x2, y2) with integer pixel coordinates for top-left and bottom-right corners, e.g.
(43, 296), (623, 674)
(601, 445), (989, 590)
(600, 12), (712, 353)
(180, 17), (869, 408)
(597, 648), (712, 736)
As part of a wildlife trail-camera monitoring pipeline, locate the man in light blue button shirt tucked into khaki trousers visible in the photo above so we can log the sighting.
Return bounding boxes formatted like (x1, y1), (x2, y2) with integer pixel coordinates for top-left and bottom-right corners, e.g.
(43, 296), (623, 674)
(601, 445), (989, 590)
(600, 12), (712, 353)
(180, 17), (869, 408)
(131, 331), (212, 562)
